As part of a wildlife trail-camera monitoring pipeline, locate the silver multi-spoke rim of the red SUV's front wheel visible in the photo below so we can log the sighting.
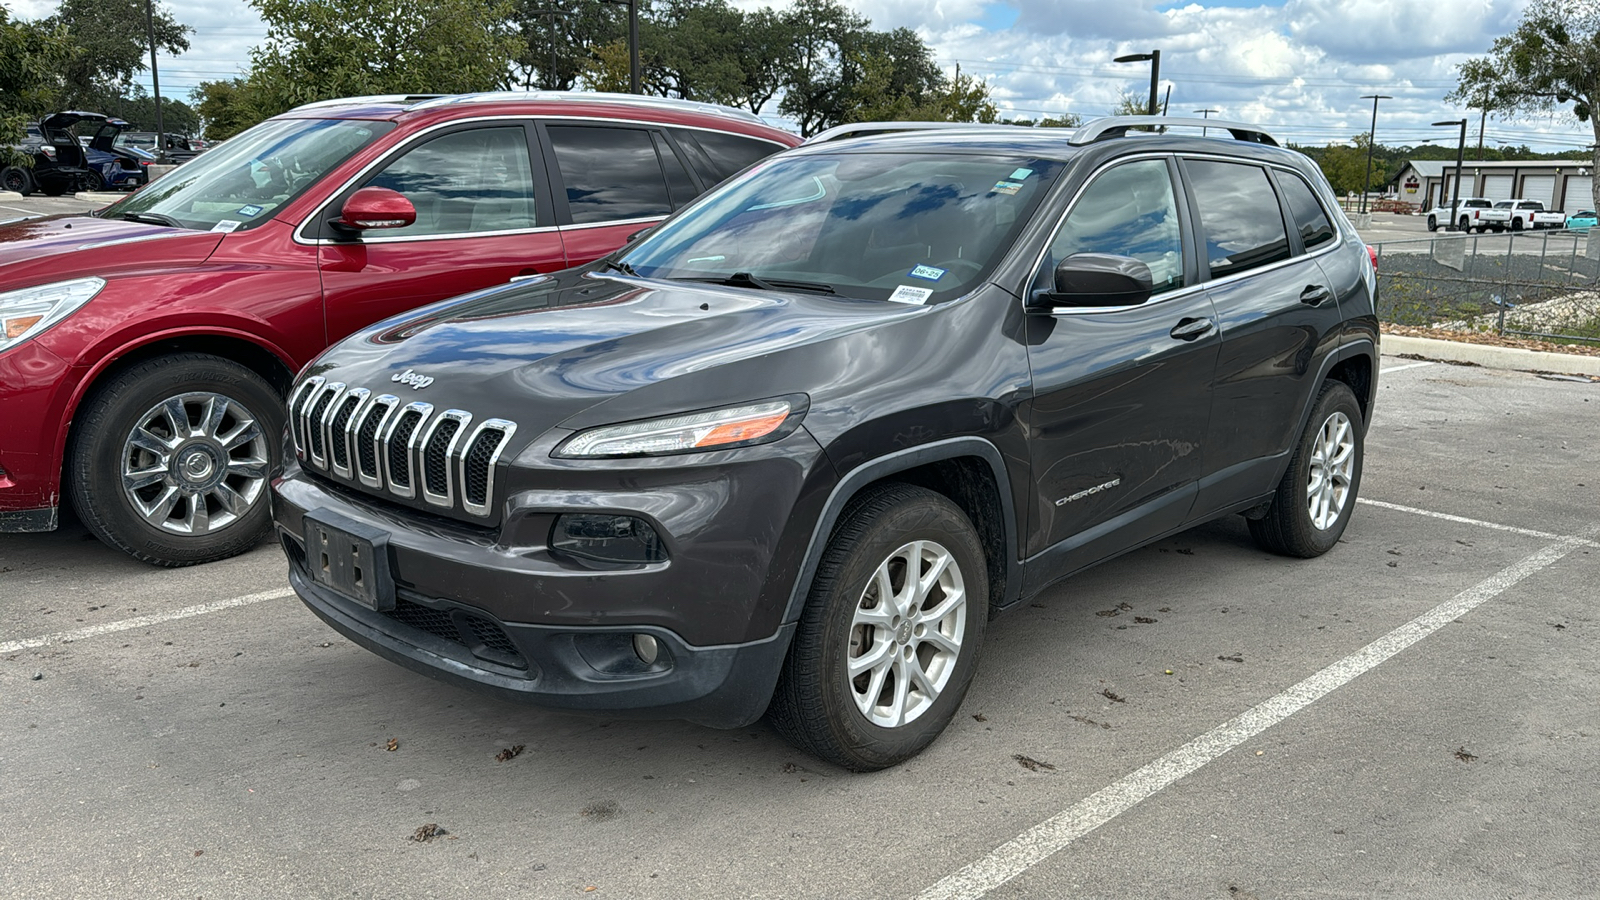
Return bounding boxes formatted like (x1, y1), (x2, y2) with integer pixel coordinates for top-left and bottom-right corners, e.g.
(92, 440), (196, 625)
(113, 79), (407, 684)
(122, 392), (269, 535)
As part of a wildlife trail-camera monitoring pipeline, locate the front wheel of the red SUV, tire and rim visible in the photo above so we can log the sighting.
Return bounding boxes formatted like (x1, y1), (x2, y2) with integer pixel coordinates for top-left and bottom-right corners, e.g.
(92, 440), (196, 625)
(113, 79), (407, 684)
(69, 354), (283, 567)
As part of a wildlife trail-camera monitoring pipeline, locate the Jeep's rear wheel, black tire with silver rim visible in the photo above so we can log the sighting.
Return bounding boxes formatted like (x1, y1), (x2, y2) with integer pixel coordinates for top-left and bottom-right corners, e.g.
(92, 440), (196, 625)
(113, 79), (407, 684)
(1250, 381), (1366, 559)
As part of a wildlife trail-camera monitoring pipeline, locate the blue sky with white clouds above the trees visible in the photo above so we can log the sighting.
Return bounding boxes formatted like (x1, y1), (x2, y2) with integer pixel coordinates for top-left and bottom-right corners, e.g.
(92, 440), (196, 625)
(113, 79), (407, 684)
(9, 0), (1594, 152)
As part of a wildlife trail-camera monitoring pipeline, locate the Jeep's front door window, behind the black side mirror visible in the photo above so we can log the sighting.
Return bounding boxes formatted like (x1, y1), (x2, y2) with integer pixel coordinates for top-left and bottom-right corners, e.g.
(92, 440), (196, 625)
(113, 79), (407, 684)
(1040, 160), (1184, 295)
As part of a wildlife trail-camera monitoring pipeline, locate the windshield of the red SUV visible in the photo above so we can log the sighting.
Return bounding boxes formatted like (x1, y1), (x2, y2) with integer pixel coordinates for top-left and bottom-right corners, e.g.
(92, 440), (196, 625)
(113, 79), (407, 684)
(99, 119), (394, 231)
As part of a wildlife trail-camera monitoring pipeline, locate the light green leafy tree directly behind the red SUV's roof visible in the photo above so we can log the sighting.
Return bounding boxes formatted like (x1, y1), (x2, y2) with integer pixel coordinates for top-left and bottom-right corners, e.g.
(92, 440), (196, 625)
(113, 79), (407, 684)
(250, 0), (518, 115)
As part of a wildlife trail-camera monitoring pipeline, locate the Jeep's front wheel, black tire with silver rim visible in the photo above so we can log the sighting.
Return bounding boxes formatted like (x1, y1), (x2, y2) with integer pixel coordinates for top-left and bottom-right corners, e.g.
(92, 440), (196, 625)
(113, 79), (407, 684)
(768, 484), (989, 772)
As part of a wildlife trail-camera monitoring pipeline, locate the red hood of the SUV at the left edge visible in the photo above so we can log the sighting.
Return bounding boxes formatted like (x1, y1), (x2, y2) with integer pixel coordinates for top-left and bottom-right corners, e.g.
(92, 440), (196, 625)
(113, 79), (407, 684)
(0, 216), (222, 290)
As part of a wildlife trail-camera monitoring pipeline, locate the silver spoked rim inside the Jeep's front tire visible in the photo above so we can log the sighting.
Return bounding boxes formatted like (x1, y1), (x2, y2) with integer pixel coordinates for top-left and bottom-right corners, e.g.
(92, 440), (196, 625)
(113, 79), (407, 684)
(846, 541), (966, 729)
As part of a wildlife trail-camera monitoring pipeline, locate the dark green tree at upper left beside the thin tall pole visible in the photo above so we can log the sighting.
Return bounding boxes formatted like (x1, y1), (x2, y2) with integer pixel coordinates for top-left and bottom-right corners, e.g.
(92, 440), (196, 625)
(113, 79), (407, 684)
(45, 0), (194, 109)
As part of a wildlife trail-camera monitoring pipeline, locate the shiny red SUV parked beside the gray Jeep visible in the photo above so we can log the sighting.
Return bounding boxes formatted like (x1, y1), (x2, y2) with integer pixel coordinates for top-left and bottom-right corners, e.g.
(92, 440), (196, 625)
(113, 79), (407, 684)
(0, 93), (800, 565)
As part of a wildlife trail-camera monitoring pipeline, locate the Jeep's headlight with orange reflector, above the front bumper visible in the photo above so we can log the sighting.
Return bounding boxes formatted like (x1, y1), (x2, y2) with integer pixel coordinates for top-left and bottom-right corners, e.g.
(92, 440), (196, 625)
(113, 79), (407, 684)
(554, 397), (805, 460)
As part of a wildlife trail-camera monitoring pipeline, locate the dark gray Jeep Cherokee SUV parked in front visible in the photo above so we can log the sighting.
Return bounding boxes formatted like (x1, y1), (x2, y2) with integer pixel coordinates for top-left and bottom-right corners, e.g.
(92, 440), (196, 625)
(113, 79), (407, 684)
(274, 117), (1378, 770)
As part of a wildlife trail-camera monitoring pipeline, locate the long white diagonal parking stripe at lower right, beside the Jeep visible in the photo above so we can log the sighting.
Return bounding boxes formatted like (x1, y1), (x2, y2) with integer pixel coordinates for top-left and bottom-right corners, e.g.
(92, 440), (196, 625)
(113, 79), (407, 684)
(918, 527), (1600, 900)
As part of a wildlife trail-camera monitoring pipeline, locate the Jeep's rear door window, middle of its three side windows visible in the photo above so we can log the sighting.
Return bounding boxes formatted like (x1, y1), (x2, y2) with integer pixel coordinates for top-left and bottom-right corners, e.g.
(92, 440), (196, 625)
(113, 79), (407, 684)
(1184, 160), (1290, 277)
